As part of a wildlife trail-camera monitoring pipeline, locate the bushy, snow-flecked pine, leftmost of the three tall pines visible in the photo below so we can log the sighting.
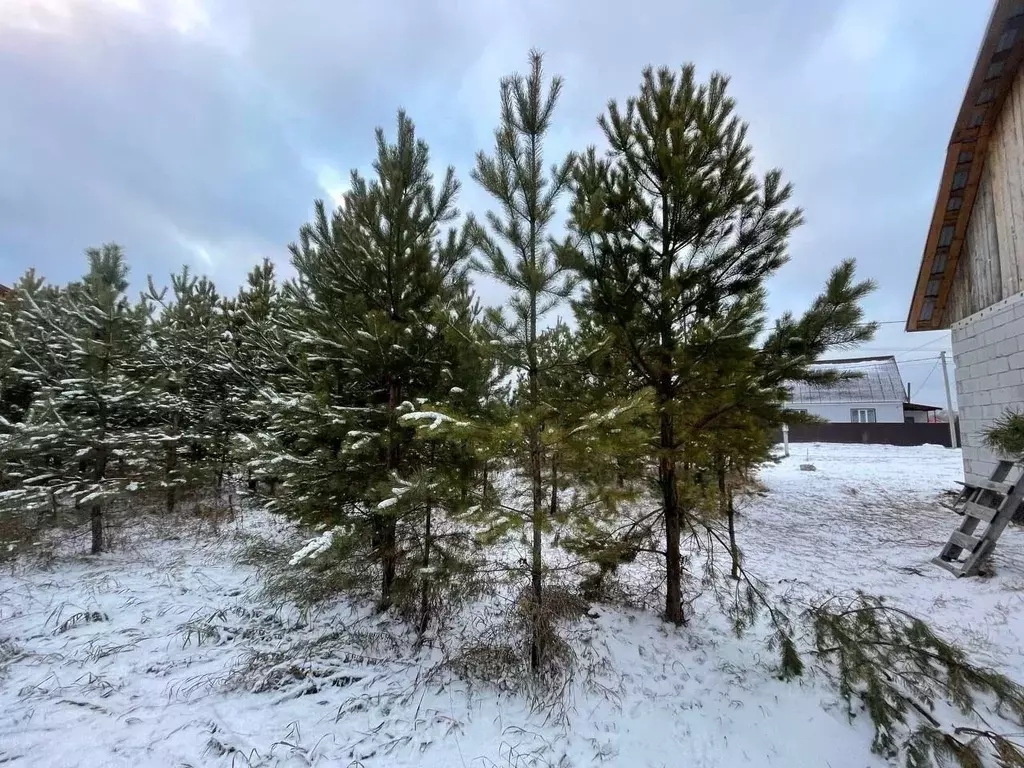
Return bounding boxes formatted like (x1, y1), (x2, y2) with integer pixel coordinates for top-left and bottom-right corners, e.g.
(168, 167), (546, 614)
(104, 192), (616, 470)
(275, 113), (470, 610)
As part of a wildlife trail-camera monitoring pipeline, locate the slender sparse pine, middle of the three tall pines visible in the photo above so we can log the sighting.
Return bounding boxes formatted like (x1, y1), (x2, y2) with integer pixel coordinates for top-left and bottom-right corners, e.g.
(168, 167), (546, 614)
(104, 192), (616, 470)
(473, 51), (573, 671)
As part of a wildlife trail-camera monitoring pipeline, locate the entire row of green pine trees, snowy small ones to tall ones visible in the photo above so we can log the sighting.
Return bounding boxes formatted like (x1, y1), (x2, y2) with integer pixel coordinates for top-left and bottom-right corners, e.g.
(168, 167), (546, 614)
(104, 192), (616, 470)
(0, 54), (874, 669)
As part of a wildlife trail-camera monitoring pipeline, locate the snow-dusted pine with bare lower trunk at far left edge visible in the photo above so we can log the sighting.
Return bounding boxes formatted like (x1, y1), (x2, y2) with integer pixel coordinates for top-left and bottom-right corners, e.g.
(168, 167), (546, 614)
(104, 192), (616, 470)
(0, 244), (150, 554)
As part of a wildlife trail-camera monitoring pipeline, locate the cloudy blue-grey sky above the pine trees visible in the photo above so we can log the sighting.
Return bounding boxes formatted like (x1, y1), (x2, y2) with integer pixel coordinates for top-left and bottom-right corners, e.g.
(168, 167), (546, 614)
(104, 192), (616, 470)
(0, 0), (990, 404)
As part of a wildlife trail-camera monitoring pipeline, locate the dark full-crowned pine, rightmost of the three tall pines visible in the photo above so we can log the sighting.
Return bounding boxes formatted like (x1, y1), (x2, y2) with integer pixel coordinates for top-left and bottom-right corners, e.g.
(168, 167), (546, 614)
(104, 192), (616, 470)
(565, 66), (870, 624)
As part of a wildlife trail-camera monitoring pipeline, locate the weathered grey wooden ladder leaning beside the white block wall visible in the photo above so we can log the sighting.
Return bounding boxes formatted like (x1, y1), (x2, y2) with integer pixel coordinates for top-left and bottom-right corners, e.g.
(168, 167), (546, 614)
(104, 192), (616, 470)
(932, 461), (1024, 577)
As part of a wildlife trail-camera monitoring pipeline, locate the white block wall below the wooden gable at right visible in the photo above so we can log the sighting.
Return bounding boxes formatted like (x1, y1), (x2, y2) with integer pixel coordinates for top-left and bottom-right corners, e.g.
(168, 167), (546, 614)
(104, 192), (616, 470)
(951, 293), (1024, 484)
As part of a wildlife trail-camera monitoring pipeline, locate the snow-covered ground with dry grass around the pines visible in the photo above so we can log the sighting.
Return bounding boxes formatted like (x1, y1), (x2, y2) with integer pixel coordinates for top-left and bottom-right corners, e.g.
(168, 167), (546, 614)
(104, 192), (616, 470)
(0, 444), (1024, 768)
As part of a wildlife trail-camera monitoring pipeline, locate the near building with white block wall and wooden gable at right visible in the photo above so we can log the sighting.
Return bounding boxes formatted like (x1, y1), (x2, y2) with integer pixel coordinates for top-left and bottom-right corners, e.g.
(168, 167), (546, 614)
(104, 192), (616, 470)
(906, 0), (1024, 484)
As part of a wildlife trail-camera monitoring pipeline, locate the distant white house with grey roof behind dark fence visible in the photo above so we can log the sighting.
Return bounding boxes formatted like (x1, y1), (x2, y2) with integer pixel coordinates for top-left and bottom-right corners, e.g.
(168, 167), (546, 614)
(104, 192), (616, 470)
(787, 355), (938, 424)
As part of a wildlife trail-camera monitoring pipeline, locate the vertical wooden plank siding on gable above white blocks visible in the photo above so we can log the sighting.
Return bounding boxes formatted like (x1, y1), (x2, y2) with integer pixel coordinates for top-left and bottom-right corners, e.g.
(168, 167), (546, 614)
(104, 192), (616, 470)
(943, 62), (1024, 326)
